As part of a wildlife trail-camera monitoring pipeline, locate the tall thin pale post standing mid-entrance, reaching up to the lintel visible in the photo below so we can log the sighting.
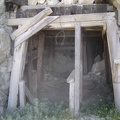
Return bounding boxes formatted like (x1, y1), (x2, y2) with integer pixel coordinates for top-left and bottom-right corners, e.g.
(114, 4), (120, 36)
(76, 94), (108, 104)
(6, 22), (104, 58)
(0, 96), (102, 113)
(75, 24), (82, 116)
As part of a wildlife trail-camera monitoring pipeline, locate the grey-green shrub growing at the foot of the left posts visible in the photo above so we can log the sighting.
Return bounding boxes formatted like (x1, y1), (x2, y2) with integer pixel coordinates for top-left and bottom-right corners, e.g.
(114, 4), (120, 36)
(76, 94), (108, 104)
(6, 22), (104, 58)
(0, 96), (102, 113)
(1, 99), (72, 120)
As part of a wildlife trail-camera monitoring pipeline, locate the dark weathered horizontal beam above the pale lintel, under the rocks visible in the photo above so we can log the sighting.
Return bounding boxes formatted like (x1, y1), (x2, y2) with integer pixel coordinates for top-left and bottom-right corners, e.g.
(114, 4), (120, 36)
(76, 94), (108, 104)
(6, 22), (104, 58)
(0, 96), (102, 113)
(21, 4), (113, 17)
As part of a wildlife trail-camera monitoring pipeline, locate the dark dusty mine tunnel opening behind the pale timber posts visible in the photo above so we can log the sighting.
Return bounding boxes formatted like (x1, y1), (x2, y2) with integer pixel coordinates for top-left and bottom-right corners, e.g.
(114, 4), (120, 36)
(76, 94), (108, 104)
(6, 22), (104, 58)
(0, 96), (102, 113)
(24, 29), (112, 103)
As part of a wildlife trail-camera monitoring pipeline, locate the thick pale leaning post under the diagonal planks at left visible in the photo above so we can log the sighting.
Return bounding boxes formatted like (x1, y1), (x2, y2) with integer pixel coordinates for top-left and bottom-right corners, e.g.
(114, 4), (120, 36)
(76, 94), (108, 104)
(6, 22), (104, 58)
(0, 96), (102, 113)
(8, 41), (28, 109)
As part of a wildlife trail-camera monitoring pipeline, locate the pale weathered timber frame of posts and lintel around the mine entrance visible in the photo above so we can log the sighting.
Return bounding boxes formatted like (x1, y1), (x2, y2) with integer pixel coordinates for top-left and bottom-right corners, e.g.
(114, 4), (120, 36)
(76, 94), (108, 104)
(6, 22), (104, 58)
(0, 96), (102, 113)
(8, 9), (120, 116)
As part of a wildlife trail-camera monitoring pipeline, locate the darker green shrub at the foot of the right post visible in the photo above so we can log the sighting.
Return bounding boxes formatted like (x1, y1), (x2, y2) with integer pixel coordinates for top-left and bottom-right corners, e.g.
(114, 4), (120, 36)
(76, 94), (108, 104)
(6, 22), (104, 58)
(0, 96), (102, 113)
(82, 102), (120, 120)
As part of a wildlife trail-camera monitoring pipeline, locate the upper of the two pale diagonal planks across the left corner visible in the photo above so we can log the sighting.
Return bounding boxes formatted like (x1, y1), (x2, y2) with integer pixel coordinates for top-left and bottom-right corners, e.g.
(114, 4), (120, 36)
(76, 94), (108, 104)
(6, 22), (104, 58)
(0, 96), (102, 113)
(11, 8), (52, 40)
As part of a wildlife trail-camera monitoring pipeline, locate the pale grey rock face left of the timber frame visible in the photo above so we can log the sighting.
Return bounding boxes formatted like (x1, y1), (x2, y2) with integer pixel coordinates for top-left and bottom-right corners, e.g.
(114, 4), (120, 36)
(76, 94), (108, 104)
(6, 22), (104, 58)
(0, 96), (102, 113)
(0, 0), (11, 114)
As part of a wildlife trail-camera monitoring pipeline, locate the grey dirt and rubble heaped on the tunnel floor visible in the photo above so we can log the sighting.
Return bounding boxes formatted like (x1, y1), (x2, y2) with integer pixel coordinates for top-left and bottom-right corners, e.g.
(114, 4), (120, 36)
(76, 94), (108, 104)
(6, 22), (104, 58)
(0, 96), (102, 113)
(41, 61), (113, 104)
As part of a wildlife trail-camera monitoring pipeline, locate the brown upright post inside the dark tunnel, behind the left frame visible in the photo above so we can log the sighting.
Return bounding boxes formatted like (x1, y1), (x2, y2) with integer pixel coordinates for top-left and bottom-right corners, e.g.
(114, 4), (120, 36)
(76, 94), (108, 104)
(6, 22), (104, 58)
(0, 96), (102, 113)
(37, 32), (45, 98)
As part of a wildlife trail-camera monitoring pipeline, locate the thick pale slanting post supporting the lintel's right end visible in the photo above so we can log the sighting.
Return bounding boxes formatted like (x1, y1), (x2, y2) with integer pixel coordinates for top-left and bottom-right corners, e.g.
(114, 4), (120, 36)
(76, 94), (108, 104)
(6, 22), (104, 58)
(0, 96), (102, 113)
(107, 19), (120, 110)
